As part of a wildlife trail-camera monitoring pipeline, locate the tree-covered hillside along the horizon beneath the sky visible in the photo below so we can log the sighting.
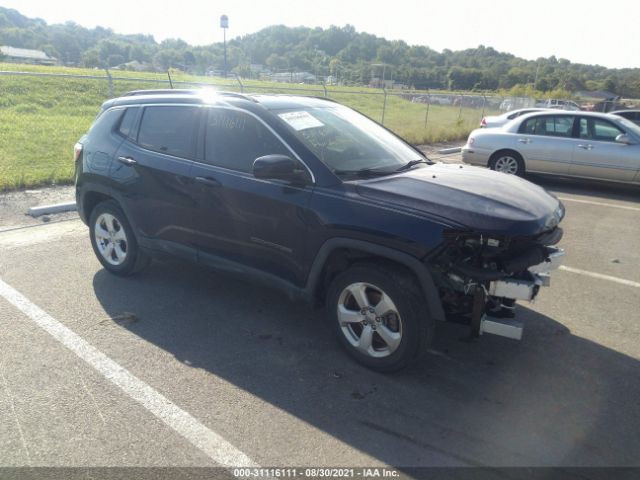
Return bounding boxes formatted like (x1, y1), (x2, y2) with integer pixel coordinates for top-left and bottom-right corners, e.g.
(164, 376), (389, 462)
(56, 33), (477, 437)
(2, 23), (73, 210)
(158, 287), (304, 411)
(0, 7), (640, 98)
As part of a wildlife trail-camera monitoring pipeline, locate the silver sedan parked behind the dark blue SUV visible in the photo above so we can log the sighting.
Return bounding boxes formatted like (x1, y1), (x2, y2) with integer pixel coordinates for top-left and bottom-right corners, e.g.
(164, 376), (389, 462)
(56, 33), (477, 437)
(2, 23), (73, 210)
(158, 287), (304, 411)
(462, 112), (640, 183)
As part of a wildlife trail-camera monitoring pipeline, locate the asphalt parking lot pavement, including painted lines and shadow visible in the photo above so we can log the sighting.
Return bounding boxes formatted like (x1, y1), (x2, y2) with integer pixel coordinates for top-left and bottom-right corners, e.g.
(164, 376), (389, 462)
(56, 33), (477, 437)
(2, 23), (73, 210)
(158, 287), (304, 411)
(0, 158), (640, 472)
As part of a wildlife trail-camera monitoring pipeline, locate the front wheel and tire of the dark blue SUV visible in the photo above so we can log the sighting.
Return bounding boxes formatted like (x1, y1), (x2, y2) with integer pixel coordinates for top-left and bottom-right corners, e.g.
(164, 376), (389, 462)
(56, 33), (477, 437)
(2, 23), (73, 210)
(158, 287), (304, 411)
(326, 263), (435, 372)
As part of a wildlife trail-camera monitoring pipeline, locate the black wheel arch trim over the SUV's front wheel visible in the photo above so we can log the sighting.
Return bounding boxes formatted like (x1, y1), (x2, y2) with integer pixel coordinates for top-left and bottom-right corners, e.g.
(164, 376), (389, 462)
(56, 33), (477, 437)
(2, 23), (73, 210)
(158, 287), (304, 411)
(306, 238), (445, 320)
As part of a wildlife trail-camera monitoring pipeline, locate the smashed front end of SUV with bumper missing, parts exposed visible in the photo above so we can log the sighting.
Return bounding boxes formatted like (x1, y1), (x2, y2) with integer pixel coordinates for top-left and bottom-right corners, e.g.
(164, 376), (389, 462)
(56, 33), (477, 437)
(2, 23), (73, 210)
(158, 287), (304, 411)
(427, 223), (564, 340)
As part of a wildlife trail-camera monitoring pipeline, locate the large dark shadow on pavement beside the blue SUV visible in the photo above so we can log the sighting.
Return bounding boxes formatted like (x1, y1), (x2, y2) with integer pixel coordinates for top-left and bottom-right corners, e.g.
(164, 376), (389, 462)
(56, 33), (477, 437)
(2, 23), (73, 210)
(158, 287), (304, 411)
(93, 261), (640, 467)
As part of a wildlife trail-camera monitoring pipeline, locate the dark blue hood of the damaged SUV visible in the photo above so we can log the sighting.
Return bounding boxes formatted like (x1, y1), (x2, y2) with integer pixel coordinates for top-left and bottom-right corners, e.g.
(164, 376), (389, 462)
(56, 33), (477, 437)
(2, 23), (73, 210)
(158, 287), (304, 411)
(356, 163), (564, 235)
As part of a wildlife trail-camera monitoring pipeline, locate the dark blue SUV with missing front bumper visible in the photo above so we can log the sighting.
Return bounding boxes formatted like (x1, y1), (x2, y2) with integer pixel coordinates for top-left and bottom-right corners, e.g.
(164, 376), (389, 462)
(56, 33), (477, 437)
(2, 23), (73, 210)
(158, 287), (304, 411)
(75, 91), (564, 371)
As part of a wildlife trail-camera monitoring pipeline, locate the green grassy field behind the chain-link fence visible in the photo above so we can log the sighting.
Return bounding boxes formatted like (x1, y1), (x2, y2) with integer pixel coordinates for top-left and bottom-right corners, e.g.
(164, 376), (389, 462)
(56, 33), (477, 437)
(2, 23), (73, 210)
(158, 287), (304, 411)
(0, 63), (496, 190)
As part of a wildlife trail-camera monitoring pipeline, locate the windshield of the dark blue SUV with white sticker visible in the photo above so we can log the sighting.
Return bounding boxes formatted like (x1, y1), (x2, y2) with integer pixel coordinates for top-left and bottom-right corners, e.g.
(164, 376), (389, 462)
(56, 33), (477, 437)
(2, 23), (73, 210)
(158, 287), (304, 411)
(275, 105), (424, 173)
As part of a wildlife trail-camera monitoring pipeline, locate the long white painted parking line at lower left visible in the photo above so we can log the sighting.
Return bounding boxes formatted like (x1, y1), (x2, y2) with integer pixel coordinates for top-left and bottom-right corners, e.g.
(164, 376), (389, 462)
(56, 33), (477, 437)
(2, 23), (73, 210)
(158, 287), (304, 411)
(0, 279), (258, 467)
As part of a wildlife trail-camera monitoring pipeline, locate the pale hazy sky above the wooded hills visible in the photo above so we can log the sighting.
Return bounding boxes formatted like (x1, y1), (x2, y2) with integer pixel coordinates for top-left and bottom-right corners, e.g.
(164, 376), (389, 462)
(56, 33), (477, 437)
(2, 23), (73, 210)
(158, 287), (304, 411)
(5, 0), (640, 68)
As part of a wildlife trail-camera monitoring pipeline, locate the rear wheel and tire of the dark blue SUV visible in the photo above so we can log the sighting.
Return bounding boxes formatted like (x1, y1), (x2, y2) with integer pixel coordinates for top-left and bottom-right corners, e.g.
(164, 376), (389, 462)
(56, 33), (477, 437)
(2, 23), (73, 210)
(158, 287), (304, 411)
(89, 200), (150, 277)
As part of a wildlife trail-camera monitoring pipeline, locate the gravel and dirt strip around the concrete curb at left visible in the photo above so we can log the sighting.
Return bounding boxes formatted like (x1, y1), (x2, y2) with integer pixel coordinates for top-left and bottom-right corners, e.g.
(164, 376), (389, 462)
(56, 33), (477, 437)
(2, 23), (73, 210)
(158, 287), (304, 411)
(0, 185), (78, 231)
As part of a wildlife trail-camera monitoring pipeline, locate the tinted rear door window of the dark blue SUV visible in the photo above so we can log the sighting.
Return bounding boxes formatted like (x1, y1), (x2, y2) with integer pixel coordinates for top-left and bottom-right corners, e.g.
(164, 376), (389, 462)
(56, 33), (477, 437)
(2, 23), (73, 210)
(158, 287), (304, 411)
(138, 106), (200, 158)
